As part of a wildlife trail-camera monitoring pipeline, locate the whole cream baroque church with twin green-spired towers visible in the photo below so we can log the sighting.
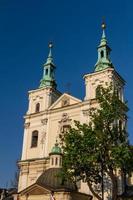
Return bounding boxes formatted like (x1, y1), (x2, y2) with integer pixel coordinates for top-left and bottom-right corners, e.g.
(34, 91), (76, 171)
(18, 24), (131, 200)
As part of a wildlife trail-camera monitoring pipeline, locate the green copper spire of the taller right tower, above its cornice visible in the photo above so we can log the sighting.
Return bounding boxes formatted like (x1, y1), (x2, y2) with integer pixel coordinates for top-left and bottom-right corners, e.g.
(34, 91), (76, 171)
(95, 22), (113, 72)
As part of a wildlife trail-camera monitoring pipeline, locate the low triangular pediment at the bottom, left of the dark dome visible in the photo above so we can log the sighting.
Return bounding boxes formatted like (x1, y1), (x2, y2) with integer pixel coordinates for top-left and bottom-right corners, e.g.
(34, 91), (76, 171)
(20, 183), (50, 195)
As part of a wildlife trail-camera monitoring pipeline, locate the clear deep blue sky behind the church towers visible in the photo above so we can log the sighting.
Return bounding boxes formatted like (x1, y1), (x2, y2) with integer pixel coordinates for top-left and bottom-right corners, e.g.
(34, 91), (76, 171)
(0, 0), (133, 187)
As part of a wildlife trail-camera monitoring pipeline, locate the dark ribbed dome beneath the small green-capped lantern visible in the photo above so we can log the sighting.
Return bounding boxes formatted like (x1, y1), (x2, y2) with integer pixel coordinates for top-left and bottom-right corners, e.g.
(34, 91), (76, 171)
(36, 168), (76, 191)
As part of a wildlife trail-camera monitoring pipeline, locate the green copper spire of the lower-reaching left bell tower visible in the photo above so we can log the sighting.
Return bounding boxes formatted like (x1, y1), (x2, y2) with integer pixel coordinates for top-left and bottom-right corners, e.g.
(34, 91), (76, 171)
(39, 43), (56, 88)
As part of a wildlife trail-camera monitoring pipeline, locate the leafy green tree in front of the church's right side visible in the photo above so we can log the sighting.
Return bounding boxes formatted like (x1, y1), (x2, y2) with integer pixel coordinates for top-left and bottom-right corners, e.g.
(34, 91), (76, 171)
(61, 86), (133, 200)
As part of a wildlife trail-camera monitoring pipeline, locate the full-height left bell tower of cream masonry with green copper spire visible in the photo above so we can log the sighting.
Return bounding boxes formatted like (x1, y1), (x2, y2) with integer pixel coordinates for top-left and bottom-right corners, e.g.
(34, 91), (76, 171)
(18, 43), (61, 191)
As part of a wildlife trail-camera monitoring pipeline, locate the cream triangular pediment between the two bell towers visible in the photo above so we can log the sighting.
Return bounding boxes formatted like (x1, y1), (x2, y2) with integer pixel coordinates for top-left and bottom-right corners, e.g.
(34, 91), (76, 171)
(49, 93), (82, 110)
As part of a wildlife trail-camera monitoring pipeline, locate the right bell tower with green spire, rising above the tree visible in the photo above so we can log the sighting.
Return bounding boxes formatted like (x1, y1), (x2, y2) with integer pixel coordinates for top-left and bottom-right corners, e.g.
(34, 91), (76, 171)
(84, 23), (125, 101)
